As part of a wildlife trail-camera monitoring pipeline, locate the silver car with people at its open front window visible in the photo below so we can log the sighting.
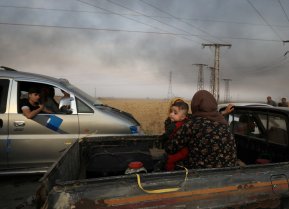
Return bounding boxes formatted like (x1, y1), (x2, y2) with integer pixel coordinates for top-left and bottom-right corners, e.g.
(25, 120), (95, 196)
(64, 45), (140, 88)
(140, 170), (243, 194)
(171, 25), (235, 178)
(0, 67), (141, 174)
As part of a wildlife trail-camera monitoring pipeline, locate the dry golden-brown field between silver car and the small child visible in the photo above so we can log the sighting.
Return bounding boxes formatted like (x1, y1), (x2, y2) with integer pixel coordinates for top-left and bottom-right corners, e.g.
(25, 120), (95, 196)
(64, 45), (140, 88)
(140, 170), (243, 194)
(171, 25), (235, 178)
(100, 98), (189, 134)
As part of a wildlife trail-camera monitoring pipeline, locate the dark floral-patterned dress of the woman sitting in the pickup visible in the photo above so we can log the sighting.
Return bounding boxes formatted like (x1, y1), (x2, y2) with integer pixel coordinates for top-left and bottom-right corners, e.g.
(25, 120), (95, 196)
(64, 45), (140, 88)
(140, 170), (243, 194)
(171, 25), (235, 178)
(165, 117), (237, 169)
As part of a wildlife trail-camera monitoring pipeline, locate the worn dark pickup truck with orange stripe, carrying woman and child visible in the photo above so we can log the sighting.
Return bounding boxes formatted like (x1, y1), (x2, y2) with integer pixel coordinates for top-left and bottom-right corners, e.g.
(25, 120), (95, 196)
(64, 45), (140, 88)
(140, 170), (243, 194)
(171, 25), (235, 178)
(37, 106), (289, 209)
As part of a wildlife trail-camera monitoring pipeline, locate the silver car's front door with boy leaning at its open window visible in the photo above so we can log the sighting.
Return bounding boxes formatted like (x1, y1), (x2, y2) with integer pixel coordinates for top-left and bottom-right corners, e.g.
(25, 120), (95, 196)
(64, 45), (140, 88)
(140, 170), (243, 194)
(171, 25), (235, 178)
(9, 81), (79, 168)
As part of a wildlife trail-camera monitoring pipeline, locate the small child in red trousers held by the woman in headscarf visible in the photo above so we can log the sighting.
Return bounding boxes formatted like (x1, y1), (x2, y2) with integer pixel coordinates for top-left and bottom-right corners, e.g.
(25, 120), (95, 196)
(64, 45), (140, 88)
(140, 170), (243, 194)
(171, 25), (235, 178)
(164, 101), (189, 171)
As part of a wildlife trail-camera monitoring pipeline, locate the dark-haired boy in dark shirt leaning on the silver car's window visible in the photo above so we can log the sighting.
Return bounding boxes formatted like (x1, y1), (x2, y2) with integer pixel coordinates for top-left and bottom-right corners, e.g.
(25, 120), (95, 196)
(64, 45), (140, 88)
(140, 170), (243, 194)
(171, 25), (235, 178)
(21, 87), (52, 119)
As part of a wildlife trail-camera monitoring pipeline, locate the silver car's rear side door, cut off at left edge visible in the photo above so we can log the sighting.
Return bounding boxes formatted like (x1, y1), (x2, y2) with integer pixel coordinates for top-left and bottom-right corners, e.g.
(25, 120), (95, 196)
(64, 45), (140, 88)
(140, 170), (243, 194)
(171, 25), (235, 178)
(0, 78), (10, 169)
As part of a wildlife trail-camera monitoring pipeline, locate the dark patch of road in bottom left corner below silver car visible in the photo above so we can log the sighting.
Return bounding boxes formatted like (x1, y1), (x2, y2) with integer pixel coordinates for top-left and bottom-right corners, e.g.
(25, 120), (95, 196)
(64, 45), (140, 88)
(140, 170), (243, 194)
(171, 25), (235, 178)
(0, 175), (41, 209)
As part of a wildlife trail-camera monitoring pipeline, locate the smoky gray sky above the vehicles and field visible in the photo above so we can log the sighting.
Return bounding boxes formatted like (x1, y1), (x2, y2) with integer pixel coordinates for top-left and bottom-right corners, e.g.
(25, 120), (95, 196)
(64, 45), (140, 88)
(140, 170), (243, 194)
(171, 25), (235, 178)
(0, 0), (289, 101)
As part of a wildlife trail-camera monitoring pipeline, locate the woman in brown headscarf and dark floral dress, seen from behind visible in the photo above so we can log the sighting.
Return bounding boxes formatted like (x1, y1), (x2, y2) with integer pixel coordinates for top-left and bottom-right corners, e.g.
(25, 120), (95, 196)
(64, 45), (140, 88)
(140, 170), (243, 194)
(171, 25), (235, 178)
(165, 90), (237, 169)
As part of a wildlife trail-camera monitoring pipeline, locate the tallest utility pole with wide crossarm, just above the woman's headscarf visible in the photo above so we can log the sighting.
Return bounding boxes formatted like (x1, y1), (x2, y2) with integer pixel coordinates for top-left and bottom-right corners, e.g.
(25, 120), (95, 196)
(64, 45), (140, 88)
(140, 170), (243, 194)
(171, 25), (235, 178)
(202, 44), (232, 102)
